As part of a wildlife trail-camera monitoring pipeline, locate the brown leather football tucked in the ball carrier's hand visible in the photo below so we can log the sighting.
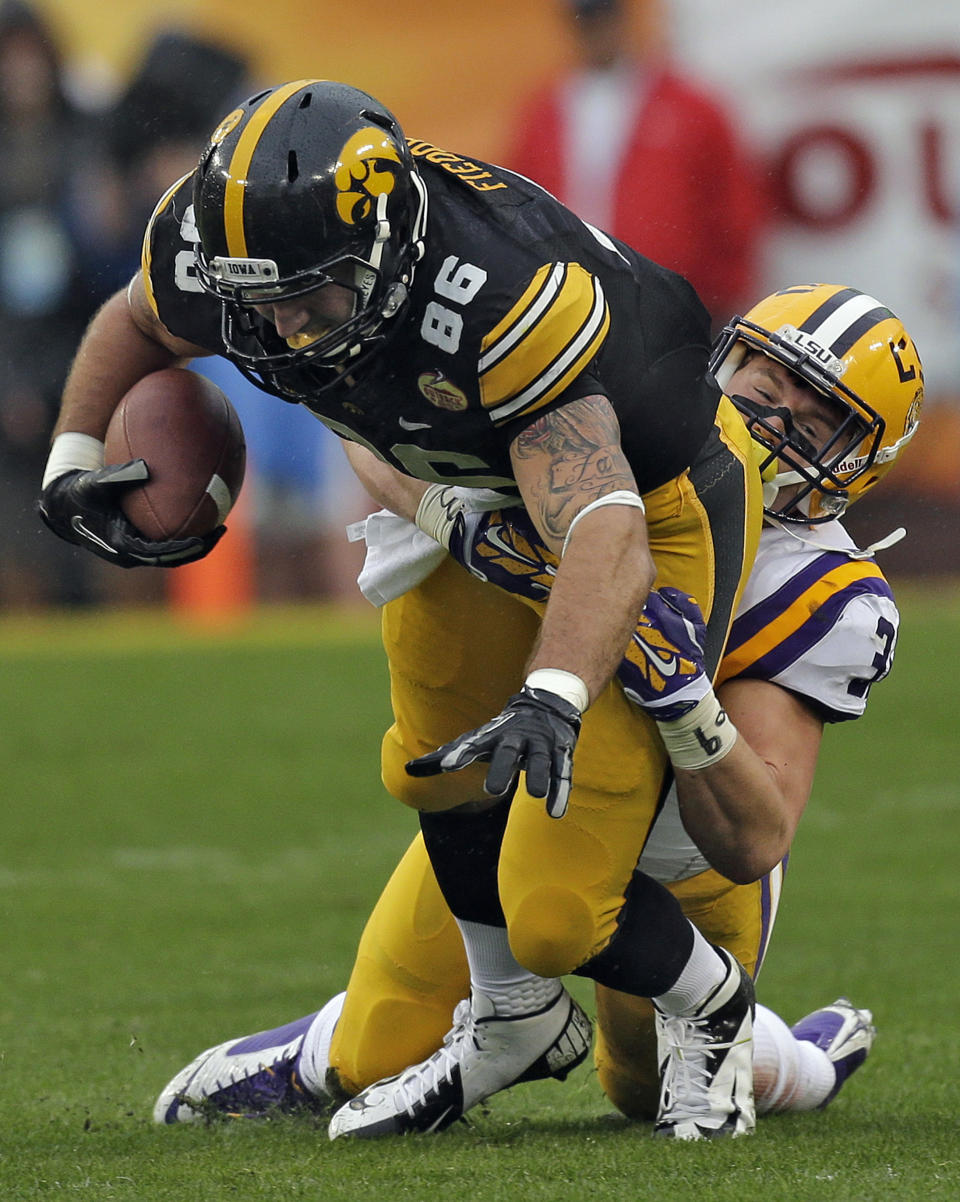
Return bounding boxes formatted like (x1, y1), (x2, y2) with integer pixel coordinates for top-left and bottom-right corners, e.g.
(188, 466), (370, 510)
(105, 368), (246, 540)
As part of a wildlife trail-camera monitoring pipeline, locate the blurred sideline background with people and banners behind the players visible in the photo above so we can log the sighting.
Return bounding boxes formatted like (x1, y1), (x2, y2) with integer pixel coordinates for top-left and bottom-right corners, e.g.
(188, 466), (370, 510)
(0, 0), (960, 613)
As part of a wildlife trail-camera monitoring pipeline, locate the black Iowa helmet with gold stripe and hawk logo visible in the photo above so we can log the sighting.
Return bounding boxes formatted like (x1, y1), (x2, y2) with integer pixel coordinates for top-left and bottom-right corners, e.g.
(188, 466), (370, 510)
(193, 79), (427, 400)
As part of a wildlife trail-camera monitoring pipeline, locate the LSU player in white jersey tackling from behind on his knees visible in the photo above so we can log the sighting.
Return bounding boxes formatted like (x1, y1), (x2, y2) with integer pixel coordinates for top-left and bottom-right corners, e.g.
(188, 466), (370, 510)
(155, 285), (923, 1138)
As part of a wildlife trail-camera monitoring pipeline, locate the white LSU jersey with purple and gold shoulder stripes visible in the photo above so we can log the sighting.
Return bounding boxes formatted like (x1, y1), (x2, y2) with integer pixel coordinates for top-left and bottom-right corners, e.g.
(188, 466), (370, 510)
(638, 522), (900, 881)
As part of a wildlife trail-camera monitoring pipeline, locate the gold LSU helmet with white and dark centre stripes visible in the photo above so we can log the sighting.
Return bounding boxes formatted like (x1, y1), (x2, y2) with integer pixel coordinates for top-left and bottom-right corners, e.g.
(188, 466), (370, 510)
(710, 284), (923, 523)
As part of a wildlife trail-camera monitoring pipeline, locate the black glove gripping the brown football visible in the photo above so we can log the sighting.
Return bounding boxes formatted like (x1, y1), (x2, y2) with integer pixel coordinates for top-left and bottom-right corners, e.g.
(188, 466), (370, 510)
(37, 459), (226, 567)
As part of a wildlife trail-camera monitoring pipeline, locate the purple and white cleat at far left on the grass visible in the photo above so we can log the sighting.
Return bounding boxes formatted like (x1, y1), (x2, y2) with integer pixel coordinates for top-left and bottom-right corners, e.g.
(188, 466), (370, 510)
(154, 995), (342, 1124)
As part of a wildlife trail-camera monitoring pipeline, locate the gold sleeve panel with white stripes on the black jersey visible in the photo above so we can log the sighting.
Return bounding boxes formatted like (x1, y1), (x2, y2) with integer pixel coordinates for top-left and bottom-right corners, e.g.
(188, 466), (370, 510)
(478, 263), (610, 423)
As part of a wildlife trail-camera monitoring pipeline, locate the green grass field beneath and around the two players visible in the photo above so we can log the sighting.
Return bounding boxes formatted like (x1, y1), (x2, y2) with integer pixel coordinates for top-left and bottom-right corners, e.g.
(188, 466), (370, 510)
(0, 590), (960, 1202)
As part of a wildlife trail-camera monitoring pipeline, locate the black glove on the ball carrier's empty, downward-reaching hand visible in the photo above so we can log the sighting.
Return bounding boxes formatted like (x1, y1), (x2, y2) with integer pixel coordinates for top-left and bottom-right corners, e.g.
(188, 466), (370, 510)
(406, 686), (580, 819)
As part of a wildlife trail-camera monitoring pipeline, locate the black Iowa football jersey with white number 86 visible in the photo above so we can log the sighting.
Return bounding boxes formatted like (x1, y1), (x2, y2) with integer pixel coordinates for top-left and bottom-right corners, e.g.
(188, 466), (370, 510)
(143, 139), (720, 493)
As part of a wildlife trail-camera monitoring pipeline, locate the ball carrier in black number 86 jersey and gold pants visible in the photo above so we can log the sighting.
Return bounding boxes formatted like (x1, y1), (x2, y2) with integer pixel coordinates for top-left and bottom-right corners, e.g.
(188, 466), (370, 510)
(41, 81), (761, 1135)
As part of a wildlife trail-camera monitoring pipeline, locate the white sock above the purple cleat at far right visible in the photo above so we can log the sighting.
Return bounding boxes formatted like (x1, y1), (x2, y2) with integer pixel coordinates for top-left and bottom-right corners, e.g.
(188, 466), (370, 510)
(753, 1004), (836, 1114)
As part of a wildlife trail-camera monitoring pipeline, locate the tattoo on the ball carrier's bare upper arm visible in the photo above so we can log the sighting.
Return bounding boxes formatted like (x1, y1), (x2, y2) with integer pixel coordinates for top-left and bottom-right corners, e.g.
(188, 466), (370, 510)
(513, 395), (637, 540)
